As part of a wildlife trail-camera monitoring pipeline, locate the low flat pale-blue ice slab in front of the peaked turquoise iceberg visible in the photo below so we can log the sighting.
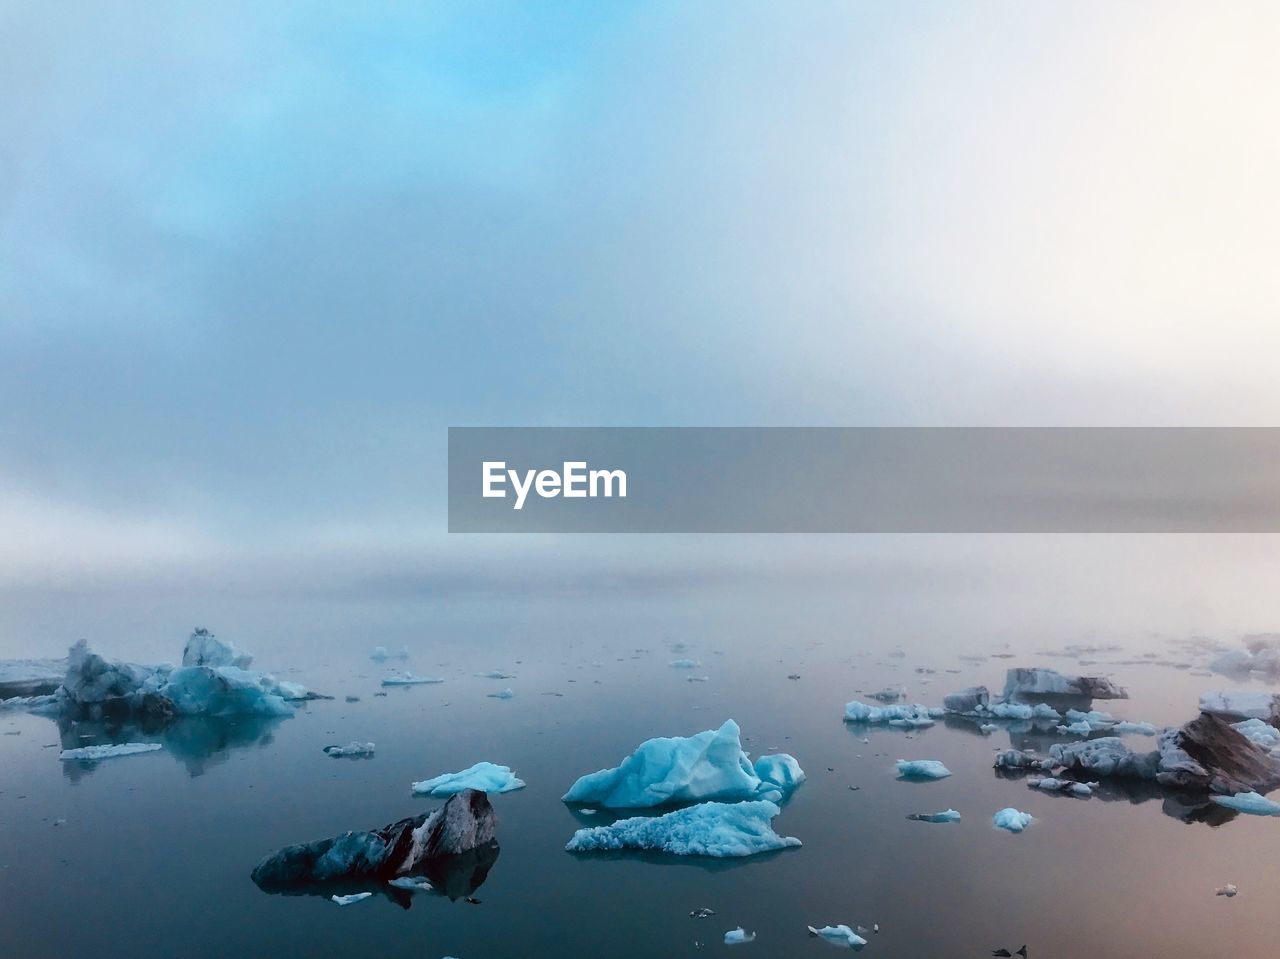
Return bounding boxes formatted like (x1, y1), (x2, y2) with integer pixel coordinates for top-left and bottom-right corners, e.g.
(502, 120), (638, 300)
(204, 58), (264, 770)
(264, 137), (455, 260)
(564, 799), (800, 858)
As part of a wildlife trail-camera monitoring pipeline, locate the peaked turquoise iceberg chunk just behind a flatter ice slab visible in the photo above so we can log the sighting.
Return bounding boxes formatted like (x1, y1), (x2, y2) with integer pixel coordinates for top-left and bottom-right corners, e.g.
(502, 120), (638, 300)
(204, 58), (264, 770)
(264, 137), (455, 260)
(564, 720), (804, 809)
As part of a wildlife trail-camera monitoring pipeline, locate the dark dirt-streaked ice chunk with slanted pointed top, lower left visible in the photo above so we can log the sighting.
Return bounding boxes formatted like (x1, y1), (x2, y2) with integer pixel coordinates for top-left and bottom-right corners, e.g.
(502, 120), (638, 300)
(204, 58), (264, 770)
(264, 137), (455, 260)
(252, 790), (498, 889)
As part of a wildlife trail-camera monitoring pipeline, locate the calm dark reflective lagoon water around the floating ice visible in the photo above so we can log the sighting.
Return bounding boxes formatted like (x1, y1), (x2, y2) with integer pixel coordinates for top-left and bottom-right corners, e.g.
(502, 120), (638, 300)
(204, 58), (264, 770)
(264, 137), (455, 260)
(0, 558), (1280, 959)
